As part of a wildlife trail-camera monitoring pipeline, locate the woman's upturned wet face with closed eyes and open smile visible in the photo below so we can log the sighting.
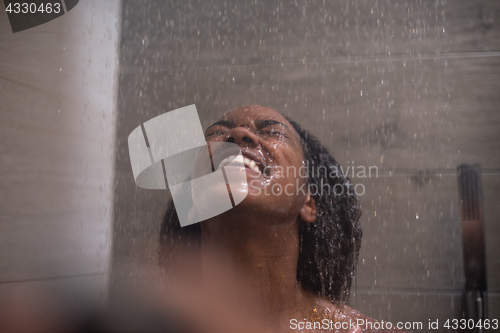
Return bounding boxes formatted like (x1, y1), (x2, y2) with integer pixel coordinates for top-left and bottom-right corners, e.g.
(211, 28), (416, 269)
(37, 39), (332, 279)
(205, 105), (307, 217)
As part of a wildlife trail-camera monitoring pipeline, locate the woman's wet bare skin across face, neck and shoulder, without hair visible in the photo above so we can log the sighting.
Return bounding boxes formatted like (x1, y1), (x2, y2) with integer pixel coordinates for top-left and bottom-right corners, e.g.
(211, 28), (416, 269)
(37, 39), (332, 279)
(195, 105), (402, 332)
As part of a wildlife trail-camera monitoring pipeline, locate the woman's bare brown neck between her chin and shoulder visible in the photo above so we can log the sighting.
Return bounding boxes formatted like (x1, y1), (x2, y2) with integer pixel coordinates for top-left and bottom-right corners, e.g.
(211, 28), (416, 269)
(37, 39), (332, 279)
(202, 209), (305, 317)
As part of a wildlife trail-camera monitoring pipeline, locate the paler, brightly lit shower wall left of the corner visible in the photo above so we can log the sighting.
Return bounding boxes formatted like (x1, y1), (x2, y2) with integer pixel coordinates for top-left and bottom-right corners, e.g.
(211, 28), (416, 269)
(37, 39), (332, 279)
(0, 0), (120, 322)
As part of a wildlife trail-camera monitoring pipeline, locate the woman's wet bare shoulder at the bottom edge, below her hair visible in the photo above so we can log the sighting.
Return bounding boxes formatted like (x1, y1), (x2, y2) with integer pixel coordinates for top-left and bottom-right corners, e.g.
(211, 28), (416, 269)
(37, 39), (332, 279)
(321, 300), (406, 333)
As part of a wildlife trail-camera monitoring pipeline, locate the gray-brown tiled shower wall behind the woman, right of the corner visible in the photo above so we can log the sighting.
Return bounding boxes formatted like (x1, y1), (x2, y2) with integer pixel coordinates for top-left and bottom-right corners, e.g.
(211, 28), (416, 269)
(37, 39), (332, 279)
(112, 0), (500, 322)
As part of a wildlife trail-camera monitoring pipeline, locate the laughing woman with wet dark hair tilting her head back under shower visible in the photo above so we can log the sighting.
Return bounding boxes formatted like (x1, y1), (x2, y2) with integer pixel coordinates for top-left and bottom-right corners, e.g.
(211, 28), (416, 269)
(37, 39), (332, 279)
(160, 106), (404, 332)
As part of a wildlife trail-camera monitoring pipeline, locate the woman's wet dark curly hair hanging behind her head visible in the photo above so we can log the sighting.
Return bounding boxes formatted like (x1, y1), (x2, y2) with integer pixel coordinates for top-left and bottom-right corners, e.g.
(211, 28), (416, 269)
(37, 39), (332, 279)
(159, 117), (362, 302)
